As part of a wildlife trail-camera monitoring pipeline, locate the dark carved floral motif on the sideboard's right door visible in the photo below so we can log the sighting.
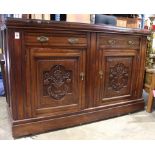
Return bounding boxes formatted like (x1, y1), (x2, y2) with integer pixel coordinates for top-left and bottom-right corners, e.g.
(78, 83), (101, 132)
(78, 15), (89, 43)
(109, 63), (129, 91)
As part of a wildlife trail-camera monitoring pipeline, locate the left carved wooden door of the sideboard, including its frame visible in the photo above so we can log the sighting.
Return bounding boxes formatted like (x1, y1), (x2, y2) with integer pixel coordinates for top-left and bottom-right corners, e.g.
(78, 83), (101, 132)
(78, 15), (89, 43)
(27, 48), (85, 117)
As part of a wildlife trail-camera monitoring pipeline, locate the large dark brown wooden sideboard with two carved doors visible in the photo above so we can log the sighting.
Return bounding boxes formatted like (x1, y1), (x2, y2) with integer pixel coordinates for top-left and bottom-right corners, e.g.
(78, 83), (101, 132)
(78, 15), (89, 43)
(1, 18), (149, 138)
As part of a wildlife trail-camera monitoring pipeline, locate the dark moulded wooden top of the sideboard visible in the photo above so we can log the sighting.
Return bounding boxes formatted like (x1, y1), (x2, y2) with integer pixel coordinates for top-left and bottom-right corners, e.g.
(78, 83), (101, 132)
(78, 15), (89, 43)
(0, 18), (150, 35)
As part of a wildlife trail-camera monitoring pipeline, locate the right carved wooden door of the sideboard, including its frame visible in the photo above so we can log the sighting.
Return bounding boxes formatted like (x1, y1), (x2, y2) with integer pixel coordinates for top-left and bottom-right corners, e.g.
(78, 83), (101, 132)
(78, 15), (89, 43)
(98, 49), (139, 104)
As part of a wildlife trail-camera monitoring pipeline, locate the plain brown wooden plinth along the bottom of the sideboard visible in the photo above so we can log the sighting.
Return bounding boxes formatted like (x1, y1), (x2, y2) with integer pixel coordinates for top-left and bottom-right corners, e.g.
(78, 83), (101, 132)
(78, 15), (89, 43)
(12, 100), (144, 138)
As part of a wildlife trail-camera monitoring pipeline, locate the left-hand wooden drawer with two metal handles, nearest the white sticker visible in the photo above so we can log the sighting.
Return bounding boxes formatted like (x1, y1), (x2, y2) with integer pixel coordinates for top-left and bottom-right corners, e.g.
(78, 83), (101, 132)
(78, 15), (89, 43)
(25, 33), (87, 46)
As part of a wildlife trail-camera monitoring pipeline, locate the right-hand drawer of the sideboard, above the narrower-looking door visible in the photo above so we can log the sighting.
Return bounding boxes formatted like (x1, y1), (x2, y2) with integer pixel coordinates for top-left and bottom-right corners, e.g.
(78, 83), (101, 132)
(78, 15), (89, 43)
(99, 35), (140, 49)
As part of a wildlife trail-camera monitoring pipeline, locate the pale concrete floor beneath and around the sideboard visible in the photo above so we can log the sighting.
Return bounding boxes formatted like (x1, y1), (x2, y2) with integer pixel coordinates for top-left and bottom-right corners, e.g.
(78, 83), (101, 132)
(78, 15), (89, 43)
(0, 91), (155, 140)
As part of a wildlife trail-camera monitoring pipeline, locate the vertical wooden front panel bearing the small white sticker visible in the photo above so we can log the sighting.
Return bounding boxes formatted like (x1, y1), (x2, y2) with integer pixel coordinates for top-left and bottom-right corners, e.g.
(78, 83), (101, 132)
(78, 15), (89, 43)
(8, 29), (24, 120)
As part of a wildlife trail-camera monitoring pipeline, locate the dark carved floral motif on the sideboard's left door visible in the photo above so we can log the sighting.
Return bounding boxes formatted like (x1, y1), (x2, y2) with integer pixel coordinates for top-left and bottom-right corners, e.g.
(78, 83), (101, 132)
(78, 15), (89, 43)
(43, 65), (72, 100)
